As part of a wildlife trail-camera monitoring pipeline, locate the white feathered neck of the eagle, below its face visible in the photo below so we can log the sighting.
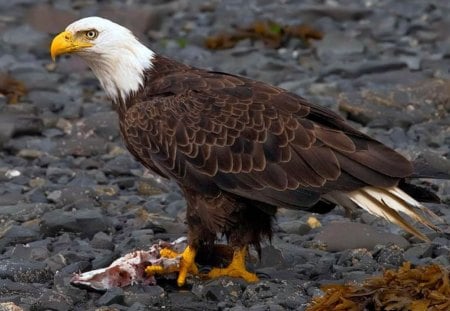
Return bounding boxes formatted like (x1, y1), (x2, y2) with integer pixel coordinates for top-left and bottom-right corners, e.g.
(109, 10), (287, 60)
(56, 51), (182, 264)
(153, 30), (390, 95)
(86, 40), (155, 102)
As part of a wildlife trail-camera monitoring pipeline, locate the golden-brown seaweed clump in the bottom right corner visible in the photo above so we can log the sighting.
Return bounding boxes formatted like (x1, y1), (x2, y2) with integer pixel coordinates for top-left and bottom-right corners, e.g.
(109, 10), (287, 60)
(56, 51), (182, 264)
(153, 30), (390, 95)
(306, 262), (450, 311)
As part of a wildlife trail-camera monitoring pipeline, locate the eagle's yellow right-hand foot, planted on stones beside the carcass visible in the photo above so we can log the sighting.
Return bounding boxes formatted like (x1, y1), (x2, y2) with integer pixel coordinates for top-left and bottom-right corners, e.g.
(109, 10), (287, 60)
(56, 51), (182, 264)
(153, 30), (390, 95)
(207, 247), (258, 282)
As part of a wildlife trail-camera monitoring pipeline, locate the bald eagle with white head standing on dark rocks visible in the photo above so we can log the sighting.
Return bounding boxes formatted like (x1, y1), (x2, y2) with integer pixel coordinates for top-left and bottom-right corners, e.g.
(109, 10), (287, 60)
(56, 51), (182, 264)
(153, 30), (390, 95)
(51, 17), (437, 286)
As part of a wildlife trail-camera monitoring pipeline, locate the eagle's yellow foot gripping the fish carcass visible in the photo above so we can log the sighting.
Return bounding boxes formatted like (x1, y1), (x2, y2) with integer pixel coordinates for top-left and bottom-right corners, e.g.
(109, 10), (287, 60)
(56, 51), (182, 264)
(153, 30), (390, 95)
(145, 246), (198, 286)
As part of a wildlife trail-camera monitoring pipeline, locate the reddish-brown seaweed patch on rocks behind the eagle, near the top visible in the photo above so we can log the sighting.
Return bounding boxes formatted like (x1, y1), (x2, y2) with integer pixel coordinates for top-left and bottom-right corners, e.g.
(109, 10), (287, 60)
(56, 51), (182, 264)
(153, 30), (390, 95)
(205, 20), (323, 50)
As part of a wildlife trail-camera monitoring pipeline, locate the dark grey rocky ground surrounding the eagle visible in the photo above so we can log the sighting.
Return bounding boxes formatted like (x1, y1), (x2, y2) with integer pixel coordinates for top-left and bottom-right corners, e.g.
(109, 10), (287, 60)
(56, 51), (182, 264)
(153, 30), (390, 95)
(0, 0), (450, 311)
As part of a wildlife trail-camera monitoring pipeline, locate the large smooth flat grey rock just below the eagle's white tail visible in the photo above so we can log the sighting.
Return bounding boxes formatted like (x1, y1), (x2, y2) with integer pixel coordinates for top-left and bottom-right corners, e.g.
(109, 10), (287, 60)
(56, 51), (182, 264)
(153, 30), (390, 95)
(314, 222), (409, 252)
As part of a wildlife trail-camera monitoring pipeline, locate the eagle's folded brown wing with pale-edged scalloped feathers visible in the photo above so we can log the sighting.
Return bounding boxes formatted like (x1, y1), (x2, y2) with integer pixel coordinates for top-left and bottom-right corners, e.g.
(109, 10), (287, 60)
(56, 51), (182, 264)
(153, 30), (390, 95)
(123, 70), (412, 207)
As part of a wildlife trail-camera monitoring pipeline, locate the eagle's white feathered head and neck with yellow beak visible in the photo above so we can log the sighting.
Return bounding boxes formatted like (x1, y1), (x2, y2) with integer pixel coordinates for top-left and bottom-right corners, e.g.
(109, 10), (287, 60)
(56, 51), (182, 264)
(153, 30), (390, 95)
(50, 17), (155, 101)
